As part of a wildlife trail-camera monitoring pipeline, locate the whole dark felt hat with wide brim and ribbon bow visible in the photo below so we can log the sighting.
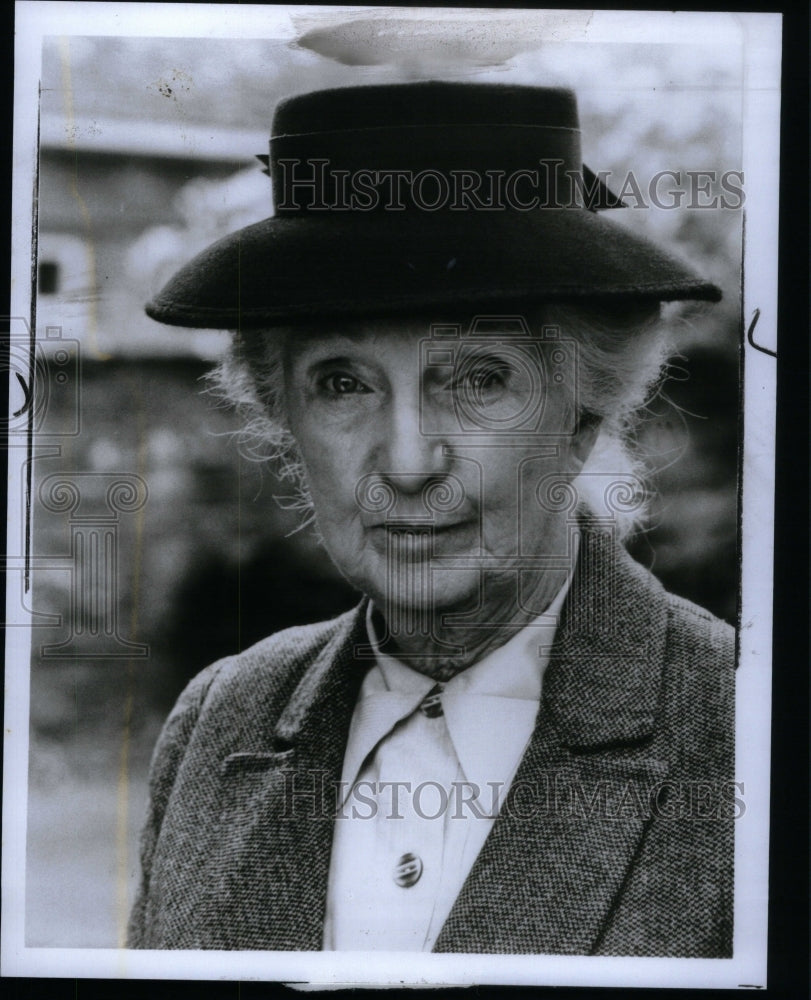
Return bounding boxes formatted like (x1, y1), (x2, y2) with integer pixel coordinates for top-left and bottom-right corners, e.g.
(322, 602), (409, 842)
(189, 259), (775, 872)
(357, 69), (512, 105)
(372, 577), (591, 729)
(146, 82), (721, 329)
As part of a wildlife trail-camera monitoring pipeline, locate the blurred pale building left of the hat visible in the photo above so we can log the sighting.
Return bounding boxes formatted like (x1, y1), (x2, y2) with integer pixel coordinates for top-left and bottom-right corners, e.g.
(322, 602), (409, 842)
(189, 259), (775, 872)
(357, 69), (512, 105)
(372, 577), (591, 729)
(37, 115), (270, 359)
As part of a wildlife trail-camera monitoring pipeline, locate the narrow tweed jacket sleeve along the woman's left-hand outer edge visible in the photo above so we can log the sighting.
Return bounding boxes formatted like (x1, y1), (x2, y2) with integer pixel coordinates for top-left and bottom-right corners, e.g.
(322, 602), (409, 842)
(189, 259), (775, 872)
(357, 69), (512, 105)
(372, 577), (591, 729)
(127, 660), (227, 948)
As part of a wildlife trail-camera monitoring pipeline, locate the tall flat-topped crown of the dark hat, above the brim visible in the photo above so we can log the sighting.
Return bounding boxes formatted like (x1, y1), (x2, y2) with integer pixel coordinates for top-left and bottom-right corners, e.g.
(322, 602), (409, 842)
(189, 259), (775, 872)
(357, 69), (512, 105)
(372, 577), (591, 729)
(270, 81), (583, 217)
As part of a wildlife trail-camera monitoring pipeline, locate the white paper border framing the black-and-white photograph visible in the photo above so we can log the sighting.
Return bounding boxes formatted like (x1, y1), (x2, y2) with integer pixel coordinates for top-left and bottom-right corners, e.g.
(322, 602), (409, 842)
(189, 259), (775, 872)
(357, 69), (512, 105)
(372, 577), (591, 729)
(0, 2), (781, 988)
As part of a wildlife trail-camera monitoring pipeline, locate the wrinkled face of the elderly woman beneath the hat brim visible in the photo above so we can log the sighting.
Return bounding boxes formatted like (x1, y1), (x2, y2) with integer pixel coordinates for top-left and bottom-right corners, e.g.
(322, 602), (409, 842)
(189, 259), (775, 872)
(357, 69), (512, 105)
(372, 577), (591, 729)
(285, 320), (593, 622)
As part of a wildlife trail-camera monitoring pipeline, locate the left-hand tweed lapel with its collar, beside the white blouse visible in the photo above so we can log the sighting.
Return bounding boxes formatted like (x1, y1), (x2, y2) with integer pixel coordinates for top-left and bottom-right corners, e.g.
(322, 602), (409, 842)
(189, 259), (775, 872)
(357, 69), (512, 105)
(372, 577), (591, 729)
(212, 604), (372, 951)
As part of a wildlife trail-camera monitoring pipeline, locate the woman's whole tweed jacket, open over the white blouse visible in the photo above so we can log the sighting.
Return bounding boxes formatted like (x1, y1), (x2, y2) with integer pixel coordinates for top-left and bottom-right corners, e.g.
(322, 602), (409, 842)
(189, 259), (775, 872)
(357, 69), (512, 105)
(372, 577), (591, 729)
(130, 530), (740, 958)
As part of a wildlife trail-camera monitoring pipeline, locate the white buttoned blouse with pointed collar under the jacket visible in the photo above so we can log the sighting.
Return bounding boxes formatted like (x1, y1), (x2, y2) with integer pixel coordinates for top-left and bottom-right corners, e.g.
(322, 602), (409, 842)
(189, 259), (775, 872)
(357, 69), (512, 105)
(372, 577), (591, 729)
(323, 578), (571, 951)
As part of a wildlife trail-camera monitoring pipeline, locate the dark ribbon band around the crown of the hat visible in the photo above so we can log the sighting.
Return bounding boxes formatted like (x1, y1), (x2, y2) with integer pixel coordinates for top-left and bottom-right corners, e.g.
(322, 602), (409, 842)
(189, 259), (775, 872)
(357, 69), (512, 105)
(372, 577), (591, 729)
(270, 125), (592, 216)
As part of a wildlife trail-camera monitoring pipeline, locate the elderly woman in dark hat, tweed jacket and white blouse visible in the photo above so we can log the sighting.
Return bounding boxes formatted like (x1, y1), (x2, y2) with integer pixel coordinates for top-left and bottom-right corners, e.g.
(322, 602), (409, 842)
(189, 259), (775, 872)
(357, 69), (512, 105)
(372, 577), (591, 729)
(131, 83), (736, 957)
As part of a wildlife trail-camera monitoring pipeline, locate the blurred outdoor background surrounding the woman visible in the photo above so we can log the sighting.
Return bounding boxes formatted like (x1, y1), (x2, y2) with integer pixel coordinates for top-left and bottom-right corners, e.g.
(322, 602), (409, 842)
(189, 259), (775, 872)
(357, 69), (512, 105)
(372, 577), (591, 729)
(21, 9), (742, 947)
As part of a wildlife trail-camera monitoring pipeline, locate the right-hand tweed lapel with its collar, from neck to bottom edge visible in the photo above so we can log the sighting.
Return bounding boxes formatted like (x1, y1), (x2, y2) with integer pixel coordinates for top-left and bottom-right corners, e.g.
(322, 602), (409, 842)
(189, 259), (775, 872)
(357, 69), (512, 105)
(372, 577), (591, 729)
(435, 531), (667, 955)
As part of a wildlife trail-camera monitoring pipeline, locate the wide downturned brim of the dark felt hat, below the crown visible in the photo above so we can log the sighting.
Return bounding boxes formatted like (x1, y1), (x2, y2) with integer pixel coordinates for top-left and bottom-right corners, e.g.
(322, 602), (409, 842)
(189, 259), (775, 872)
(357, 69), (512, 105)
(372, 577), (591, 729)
(146, 209), (721, 329)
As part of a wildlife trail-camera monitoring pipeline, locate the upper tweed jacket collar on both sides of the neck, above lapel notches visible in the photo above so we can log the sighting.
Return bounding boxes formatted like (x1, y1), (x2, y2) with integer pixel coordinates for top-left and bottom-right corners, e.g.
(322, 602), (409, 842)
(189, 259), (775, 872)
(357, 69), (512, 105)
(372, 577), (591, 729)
(275, 522), (667, 753)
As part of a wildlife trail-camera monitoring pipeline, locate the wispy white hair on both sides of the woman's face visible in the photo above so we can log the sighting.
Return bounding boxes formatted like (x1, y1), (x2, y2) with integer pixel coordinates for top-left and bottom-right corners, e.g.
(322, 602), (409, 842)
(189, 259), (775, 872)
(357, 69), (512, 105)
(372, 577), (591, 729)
(209, 302), (668, 536)
